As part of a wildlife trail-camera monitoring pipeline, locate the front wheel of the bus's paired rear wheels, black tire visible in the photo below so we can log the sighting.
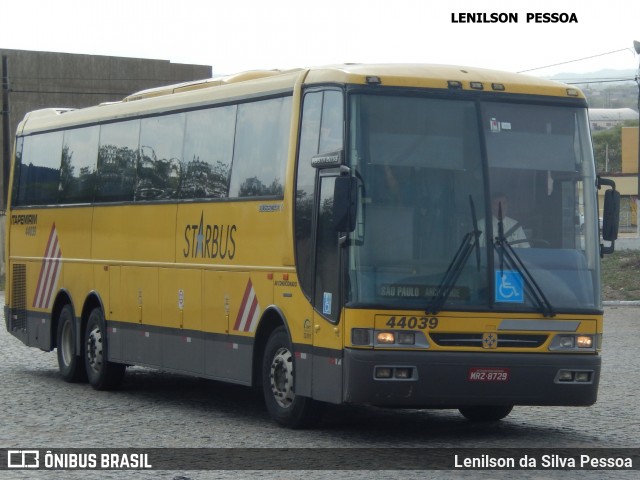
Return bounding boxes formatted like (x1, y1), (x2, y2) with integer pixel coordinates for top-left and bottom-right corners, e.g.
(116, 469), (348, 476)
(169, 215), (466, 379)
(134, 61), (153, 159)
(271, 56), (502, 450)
(84, 308), (126, 390)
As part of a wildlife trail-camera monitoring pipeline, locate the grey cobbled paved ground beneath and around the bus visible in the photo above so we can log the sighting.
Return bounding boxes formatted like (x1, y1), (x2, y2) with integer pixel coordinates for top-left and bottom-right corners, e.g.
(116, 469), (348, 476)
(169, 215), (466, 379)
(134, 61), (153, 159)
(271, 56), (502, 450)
(0, 298), (640, 480)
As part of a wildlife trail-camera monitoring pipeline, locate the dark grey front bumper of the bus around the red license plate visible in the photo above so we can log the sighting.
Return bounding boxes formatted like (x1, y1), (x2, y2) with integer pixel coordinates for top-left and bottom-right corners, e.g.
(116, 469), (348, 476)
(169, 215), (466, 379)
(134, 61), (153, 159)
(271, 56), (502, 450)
(343, 349), (602, 408)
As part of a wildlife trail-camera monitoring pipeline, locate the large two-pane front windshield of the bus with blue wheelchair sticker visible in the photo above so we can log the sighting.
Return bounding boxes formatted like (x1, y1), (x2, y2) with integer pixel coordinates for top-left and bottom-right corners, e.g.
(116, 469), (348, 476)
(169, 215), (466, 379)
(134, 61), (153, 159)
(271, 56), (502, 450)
(348, 93), (601, 315)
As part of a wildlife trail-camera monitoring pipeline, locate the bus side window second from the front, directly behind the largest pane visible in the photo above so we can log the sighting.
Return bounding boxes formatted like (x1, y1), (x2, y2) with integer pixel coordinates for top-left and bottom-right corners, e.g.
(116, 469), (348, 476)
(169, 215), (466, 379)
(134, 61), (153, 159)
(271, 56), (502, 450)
(180, 105), (237, 198)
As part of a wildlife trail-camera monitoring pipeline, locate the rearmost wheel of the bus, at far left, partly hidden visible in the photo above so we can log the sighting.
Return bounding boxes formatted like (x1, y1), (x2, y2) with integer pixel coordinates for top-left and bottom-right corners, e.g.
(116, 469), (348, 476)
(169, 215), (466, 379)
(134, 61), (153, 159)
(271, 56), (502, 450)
(56, 304), (87, 383)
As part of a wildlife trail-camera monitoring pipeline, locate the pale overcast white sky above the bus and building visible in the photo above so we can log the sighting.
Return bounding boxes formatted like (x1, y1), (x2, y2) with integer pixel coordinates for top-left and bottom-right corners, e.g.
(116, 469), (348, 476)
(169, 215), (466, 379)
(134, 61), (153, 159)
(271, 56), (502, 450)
(0, 0), (640, 80)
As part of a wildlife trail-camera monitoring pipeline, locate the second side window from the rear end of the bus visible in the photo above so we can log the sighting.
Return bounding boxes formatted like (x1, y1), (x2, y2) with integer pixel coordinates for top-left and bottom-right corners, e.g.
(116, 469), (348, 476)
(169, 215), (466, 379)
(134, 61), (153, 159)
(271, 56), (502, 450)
(59, 127), (99, 203)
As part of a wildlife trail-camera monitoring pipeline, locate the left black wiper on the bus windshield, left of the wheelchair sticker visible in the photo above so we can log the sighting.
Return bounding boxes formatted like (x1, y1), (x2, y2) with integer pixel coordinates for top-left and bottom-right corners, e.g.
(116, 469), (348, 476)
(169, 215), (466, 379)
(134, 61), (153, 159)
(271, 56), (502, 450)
(426, 195), (482, 315)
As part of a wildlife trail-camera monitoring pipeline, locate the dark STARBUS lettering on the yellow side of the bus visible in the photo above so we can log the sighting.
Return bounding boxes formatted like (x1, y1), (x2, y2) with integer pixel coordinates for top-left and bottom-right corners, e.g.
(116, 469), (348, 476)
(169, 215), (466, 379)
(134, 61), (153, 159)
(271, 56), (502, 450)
(182, 212), (238, 260)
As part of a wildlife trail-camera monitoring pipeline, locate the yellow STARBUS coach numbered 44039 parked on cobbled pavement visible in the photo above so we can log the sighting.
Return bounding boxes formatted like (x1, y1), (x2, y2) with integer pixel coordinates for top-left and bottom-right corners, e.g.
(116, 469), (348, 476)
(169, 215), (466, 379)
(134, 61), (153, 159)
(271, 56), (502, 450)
(5, 65), (618, 428)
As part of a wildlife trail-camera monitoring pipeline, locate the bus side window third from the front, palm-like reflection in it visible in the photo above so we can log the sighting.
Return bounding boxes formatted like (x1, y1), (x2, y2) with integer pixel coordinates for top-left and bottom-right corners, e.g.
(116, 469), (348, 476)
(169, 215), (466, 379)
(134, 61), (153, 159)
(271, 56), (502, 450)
(135, 113), (185, 200)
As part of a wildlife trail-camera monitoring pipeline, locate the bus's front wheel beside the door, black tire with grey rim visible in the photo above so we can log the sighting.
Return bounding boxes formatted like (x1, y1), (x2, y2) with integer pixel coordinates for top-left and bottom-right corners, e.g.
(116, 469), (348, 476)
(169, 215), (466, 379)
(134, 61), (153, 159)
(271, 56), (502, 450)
(262, 327), (323, 428)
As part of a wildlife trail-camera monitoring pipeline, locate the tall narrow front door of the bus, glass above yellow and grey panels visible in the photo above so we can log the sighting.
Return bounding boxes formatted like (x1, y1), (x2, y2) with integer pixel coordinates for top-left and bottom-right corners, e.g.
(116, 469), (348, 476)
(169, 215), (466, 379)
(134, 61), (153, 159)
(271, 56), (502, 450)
(295, 87), (344, 402)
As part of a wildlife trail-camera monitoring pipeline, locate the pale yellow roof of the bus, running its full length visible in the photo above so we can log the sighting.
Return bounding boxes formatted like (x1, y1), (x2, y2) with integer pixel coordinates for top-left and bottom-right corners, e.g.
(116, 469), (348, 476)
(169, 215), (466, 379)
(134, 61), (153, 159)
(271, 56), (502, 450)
(18, 64), (584, 135)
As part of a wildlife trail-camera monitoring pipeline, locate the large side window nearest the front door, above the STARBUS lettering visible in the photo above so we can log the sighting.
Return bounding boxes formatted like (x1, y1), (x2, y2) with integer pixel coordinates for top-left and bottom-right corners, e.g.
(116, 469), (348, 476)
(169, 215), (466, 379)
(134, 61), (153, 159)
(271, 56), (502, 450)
(229, 97), (291, 197)
